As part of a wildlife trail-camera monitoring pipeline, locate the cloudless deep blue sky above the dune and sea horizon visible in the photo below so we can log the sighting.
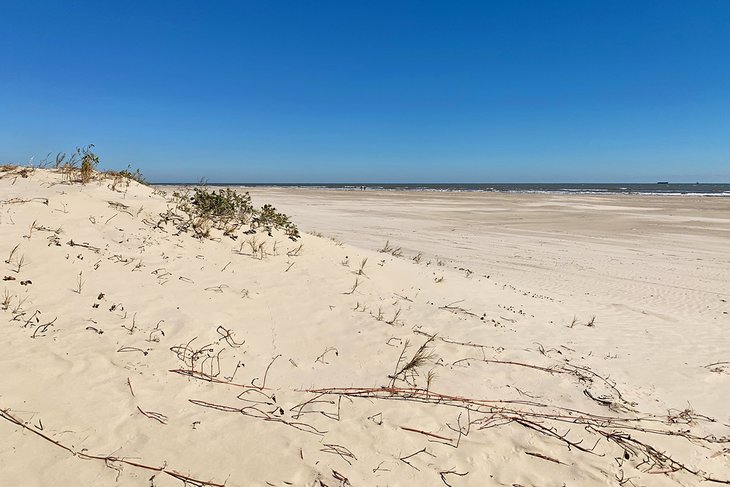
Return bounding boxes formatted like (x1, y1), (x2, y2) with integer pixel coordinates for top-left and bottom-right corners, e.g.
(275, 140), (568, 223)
(0, 0), (730, 182)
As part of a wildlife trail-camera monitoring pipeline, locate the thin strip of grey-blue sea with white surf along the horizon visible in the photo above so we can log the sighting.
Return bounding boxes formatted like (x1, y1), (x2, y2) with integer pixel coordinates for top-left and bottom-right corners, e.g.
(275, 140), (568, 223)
(162, 183), (730, 196)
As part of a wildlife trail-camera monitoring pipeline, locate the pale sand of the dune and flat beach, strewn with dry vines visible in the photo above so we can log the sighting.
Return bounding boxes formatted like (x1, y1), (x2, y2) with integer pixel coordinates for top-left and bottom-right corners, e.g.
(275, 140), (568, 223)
(0, 170), (730, 487)
